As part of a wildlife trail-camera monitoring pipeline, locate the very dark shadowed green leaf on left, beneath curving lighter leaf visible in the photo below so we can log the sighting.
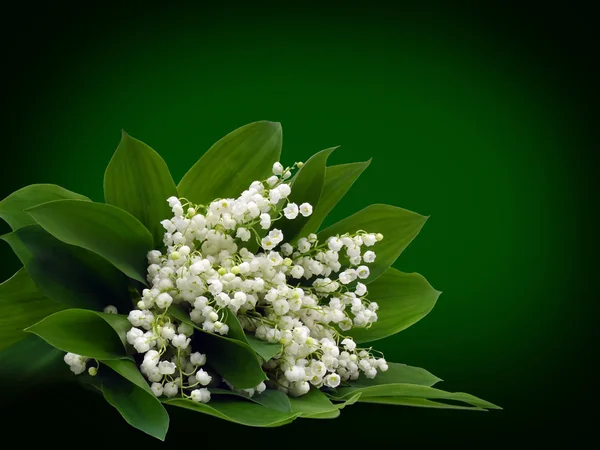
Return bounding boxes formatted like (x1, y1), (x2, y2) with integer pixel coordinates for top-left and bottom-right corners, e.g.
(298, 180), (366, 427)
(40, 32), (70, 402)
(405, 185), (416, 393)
(2, 225), (131, 312)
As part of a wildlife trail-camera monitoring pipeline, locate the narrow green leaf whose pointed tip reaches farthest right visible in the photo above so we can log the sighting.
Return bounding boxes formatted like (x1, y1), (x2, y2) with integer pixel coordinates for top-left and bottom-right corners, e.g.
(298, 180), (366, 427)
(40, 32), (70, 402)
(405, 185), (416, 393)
(331, 383), (501, 409)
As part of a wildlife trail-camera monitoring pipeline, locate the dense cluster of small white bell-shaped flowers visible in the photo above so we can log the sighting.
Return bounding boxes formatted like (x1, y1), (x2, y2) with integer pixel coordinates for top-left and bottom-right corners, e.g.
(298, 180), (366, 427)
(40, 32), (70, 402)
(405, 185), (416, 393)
(63, 163), (387, 402)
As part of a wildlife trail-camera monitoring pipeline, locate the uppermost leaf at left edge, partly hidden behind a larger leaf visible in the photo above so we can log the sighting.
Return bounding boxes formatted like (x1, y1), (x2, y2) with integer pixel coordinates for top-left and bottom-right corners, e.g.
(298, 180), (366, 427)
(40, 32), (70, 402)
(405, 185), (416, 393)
(0, 184), (89, 230)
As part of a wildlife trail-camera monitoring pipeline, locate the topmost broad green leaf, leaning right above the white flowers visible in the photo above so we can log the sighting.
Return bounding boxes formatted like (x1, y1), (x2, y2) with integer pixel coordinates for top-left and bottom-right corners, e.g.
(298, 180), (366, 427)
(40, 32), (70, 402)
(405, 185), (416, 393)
(177, 121), (281, 204)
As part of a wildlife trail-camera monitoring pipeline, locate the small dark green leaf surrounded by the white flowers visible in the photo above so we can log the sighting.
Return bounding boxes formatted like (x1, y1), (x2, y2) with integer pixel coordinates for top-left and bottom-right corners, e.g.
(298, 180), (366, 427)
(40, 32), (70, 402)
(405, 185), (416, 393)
(169, 305), (267, 389)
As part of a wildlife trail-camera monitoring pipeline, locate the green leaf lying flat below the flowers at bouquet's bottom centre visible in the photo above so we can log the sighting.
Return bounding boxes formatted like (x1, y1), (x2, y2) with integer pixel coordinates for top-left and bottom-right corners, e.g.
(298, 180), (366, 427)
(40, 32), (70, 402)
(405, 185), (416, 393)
(164, 397), (299, 427)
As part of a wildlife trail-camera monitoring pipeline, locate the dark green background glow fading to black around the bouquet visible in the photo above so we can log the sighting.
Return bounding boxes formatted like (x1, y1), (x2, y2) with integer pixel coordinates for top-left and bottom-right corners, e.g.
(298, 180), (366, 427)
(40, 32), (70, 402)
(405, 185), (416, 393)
(0, 4), (597, 448)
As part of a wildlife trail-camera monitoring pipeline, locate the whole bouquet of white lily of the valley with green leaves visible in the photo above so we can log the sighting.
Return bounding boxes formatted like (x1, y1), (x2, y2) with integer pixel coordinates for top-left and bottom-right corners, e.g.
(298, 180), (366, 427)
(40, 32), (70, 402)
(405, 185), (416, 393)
(0, 122), (497, 439)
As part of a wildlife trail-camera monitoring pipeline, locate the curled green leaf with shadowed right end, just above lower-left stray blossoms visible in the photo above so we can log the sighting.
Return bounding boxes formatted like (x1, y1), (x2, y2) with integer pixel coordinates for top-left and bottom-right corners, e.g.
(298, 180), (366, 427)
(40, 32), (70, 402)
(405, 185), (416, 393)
(26, 309), (131, 359)
